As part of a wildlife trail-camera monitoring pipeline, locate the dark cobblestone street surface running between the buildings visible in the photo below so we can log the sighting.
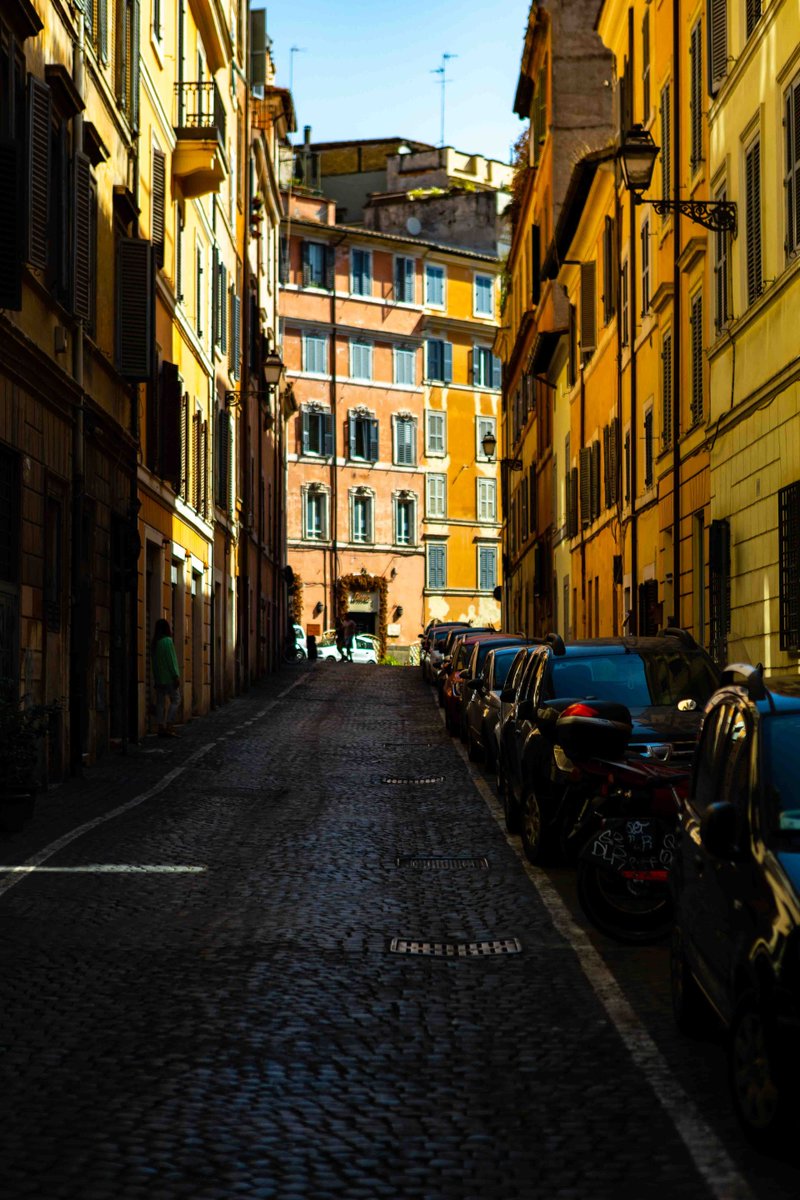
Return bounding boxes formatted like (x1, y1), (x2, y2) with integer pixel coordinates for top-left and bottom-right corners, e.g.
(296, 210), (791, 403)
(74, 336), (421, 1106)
(0, 664), (800, 1200)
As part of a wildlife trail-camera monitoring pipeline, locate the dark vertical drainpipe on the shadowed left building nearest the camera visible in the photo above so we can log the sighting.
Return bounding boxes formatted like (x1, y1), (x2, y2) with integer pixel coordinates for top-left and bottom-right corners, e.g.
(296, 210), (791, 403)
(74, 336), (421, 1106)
(70, 12), (89, 775)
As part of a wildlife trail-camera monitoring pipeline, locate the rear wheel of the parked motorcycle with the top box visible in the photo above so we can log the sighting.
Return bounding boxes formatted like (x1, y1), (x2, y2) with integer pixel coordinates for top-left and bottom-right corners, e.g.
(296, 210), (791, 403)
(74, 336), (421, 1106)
(578, 859), (673, 943)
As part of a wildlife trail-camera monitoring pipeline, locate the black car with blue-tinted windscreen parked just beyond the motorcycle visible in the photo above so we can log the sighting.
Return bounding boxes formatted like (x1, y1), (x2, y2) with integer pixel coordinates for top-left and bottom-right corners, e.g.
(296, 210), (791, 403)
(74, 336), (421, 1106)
(501, 630), (720, 862)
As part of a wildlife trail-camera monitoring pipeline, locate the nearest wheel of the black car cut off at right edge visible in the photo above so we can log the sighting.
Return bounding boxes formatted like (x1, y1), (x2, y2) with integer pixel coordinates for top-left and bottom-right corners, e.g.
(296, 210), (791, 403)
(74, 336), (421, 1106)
(728, 994), (798, 1150)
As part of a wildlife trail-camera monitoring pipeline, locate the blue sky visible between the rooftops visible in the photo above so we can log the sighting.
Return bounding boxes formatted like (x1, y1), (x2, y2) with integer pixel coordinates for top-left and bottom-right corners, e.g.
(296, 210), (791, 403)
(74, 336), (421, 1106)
(252, 0), (530, 162)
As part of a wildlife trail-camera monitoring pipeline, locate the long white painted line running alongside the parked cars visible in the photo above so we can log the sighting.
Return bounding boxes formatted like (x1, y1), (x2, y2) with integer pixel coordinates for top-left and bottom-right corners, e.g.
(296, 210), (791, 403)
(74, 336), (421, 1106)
(450, 713), (754, 1200)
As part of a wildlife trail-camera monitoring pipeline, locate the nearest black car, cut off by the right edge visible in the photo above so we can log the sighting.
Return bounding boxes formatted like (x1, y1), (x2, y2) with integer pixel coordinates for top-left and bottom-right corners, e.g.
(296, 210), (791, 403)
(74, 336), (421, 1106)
(669, 666), (800, 1148)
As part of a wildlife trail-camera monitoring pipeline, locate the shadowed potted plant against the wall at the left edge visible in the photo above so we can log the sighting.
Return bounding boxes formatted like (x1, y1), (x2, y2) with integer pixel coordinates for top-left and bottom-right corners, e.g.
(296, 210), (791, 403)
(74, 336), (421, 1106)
(0, 680), (60, 833)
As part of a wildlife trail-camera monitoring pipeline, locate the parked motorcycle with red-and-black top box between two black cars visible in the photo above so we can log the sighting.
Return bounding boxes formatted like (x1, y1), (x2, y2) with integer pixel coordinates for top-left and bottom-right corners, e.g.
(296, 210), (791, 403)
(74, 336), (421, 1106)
(555, 703), (688, 942)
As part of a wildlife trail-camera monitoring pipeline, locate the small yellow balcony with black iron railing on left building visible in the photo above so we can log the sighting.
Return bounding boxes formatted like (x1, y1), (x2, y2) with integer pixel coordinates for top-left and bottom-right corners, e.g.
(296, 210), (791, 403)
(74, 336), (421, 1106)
(173, 79), (228, 197)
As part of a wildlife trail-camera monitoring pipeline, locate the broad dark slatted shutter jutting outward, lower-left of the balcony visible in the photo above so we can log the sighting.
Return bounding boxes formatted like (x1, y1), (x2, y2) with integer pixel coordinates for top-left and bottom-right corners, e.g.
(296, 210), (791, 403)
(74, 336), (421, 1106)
(116, 238), (155, 380)
